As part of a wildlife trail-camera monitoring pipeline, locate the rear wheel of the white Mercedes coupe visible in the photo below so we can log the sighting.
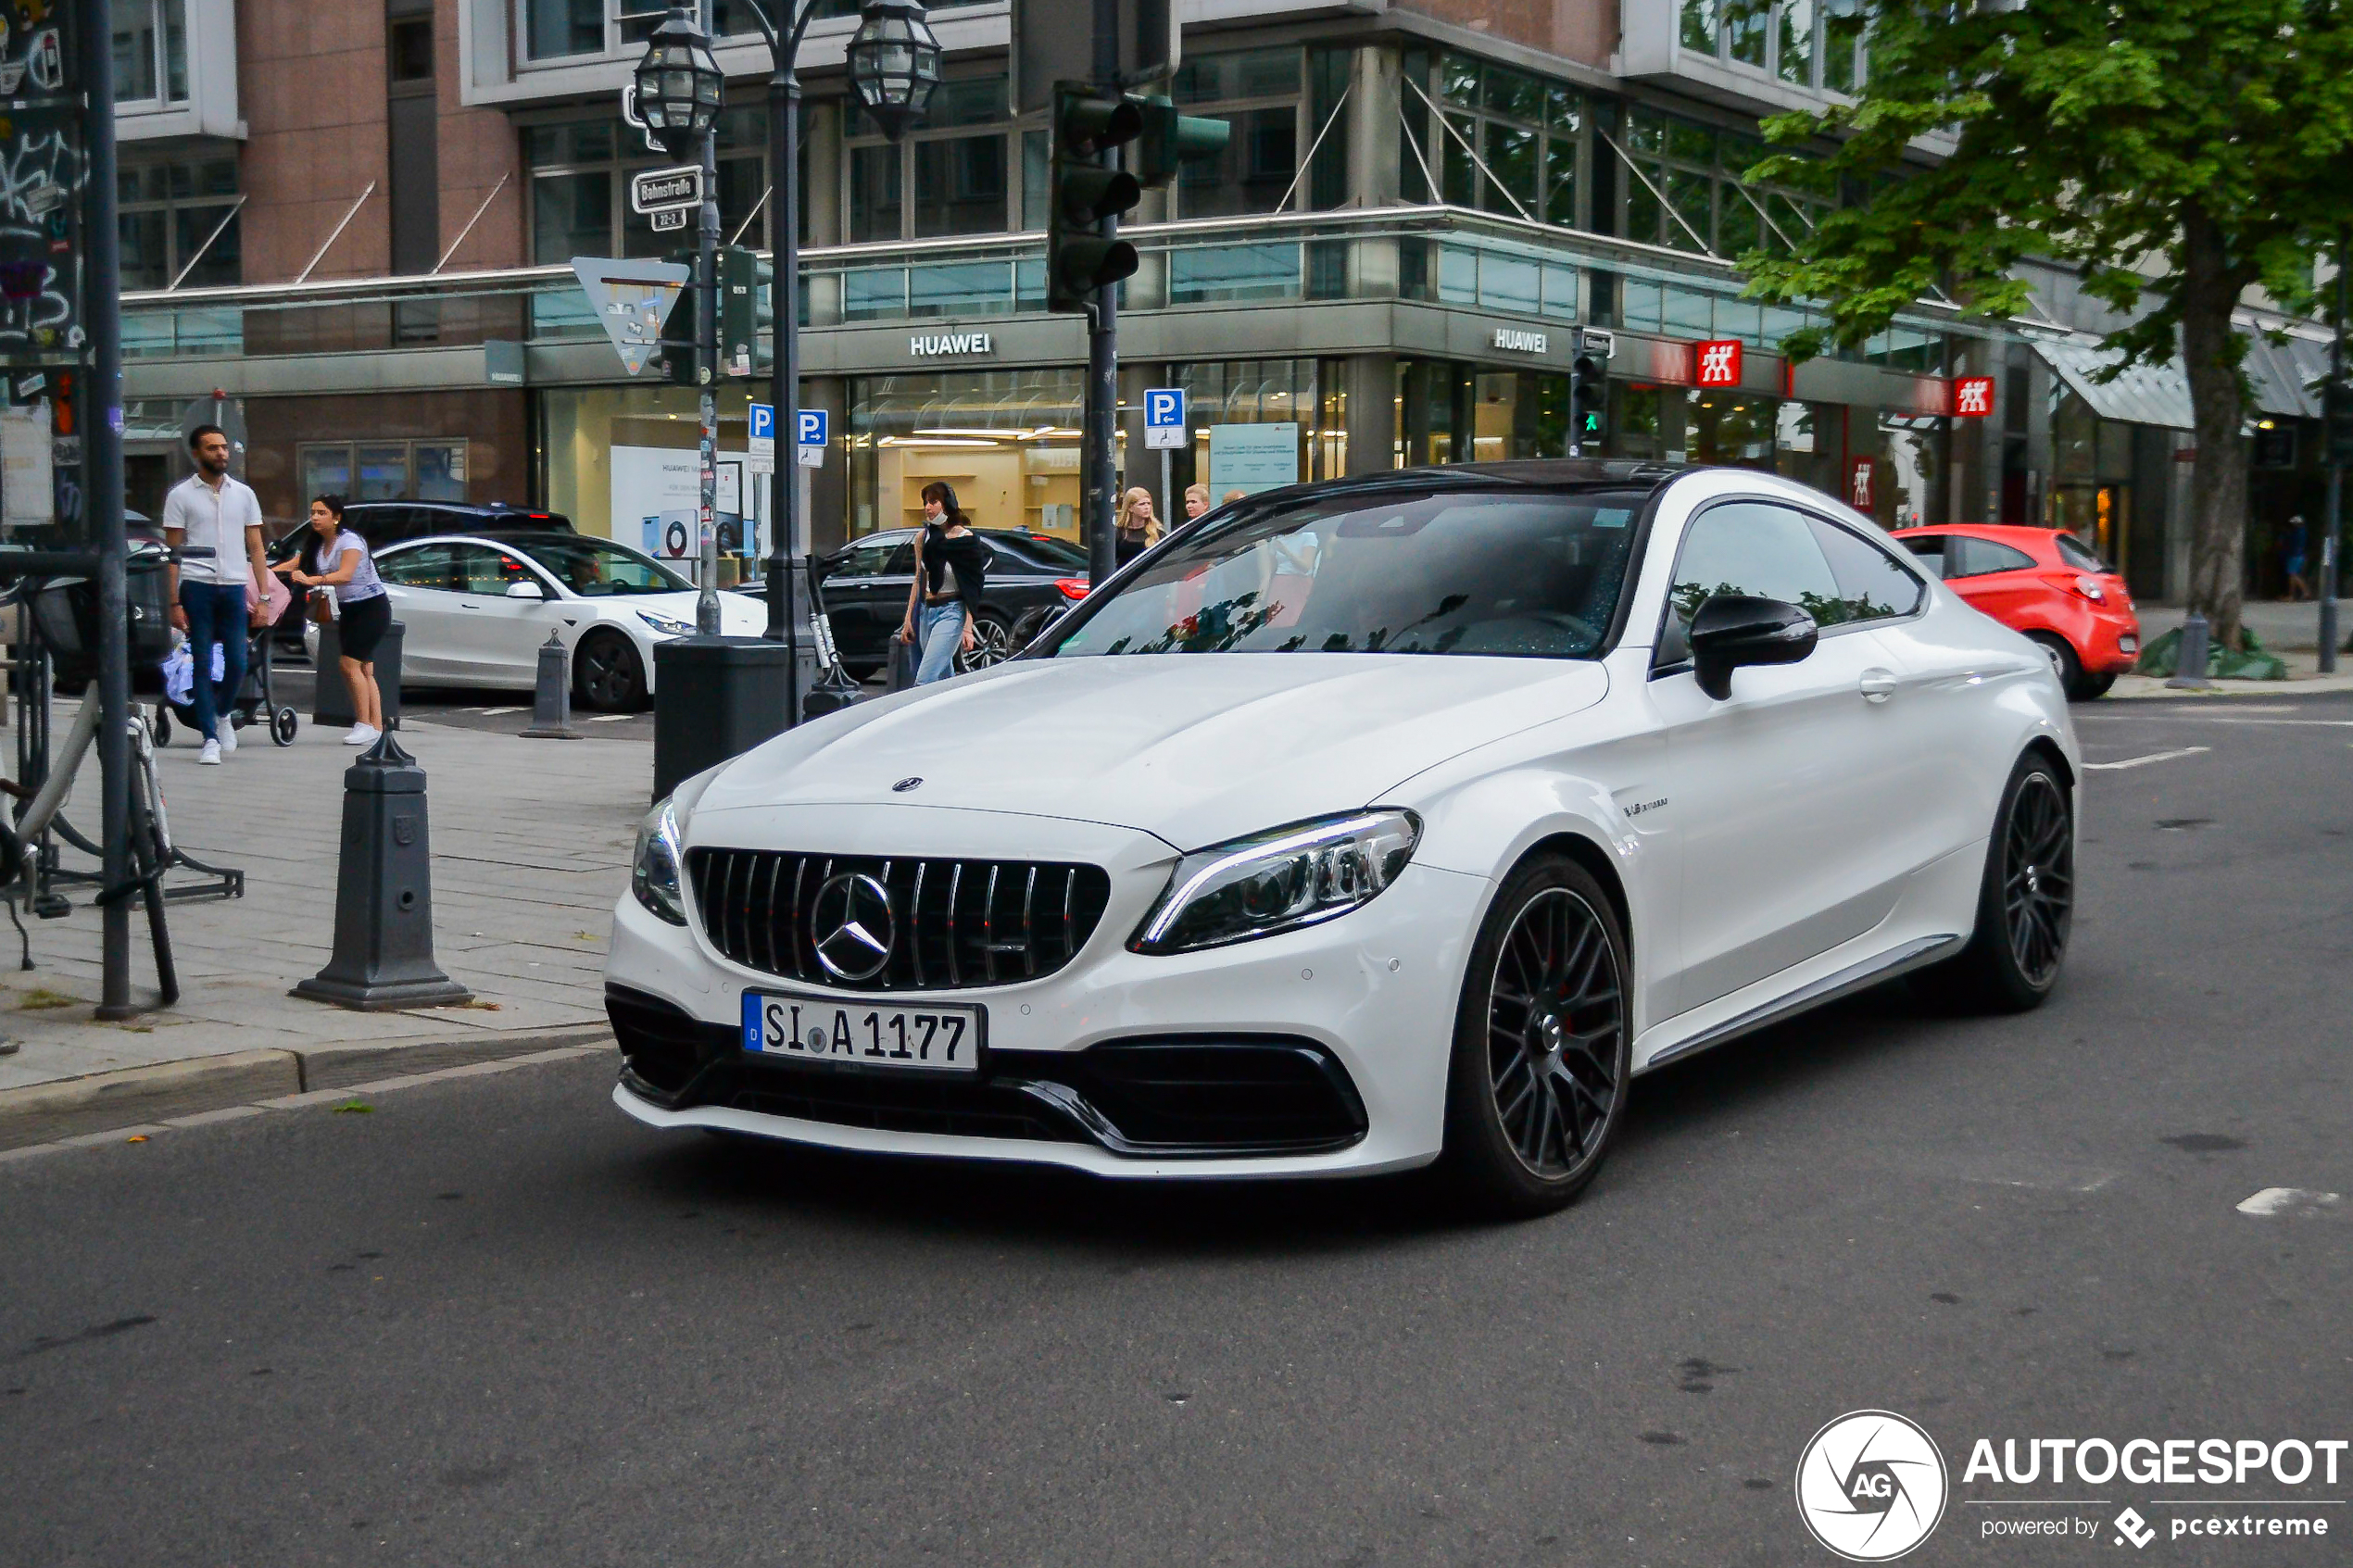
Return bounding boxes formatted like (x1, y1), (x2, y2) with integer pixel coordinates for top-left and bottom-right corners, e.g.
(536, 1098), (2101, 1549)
(1920, 752), (2075, 1013)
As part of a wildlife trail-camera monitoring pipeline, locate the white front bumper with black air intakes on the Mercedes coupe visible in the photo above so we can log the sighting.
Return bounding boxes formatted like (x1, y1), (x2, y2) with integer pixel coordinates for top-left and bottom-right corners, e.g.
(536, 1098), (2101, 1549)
(605, 868), (1487, 1178)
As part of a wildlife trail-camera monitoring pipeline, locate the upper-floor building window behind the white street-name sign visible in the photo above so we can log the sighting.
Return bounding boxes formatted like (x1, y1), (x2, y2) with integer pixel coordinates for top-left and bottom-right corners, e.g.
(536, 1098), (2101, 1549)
(522, 106), (770, 266)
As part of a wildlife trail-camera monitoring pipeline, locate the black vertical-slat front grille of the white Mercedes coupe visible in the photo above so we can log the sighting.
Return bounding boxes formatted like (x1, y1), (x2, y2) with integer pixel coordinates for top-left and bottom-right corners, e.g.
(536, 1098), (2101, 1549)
(687, 848), (1111, 992)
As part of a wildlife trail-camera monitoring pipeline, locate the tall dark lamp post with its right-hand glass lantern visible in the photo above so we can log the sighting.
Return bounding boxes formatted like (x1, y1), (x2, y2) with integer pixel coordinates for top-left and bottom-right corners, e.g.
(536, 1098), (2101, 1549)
(749, 0), (938, 724)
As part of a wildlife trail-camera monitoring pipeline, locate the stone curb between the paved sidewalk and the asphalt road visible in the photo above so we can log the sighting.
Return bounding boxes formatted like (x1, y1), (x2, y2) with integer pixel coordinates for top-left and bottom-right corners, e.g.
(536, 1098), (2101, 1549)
(0, 1025), (611, 1149)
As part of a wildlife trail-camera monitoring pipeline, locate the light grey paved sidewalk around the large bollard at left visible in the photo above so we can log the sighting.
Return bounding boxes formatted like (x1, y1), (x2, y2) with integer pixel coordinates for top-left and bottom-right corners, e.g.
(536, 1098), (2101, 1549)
(0, 703), (654, 1100)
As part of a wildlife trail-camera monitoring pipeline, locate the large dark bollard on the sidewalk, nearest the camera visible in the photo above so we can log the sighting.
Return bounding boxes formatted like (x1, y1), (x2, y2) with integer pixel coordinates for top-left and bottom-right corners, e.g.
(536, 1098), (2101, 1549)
(295, 734), (473, 1013)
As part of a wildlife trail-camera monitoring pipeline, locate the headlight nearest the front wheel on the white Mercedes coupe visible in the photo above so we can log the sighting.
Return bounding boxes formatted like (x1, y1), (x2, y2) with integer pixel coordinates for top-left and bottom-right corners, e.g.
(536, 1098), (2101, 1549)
(1127, 811), (1421, 952)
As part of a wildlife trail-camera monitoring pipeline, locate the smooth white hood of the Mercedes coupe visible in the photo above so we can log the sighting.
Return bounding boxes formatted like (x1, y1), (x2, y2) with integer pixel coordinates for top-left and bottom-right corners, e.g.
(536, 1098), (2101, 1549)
(694, 654), (1609, 848)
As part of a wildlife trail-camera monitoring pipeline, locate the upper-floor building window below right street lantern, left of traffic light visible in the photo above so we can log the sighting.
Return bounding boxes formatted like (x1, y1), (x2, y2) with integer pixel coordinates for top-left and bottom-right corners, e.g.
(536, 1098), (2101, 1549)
(842, 75), (1014, 245)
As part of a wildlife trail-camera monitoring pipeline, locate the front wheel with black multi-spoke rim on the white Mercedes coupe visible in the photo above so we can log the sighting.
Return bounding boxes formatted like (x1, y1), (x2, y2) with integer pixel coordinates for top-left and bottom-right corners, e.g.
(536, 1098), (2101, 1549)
(1440, 856), (1633, 1218)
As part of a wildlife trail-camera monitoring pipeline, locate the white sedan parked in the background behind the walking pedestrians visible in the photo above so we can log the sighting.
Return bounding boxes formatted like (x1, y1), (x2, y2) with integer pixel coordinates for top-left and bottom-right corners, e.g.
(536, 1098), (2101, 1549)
(304, 533), (767, 710)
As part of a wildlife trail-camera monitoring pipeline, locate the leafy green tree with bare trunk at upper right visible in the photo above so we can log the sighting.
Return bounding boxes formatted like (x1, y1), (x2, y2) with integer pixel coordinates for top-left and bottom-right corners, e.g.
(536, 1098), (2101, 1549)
(1727, 0), (2353, 649)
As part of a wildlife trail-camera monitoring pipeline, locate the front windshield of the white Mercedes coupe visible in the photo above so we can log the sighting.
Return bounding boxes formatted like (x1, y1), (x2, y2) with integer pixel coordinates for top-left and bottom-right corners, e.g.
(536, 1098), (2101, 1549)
(1051, 491), (1647, 659)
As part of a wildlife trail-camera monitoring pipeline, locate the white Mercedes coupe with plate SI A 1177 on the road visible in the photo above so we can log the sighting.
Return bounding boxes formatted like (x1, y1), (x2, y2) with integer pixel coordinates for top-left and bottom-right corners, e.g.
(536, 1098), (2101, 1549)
(607, 463), (2080, 1213)
